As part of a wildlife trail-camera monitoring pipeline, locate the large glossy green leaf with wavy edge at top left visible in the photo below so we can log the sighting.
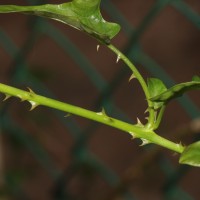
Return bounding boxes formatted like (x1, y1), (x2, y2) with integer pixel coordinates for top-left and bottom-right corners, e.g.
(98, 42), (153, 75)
(0, 0), (120, 44)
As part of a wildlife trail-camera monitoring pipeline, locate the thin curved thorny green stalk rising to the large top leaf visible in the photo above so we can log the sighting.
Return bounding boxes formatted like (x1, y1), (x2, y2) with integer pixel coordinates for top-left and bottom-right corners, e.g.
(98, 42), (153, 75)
(107, 44), (155, 128)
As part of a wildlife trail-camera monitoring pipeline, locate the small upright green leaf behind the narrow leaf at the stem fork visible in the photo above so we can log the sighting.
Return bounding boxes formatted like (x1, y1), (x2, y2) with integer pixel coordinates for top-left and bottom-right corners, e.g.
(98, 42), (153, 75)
(147, 78), (167, 109)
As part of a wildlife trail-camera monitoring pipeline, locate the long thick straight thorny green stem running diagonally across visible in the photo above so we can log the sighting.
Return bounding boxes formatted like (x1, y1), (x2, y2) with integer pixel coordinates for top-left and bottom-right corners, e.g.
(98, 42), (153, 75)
(0, 83), (184, 153)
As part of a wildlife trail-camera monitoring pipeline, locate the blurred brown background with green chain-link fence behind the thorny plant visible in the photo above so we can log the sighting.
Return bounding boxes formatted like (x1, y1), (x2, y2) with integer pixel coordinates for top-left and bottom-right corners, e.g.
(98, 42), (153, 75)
(0, 0), (200, 200)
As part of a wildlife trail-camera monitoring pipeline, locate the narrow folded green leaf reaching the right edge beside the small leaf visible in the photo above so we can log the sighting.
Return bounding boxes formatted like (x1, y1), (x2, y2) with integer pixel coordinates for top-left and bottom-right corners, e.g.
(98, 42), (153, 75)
(149, 76), (200, 103)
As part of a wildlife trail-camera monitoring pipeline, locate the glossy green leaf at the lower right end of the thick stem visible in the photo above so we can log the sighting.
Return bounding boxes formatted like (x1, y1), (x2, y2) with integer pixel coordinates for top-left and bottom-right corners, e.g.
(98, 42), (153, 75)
(179, 141), (200, 167)
